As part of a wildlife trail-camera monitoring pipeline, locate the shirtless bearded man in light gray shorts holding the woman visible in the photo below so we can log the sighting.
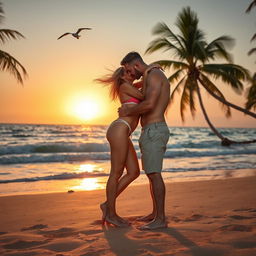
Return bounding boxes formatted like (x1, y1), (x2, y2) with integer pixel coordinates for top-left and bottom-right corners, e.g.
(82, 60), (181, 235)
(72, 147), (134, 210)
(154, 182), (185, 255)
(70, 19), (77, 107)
(119, 52), (170, 229)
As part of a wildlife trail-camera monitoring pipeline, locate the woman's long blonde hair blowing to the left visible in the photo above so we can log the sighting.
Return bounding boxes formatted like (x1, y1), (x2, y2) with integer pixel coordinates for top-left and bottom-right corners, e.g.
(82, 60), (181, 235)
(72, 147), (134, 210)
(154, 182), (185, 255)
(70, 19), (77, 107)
(95, 67), (124, 100)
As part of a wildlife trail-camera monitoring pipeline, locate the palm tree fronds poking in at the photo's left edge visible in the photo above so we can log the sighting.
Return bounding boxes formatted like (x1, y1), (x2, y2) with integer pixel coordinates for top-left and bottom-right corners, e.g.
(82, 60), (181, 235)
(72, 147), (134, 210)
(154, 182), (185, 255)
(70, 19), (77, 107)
(0, 2), (27, 84)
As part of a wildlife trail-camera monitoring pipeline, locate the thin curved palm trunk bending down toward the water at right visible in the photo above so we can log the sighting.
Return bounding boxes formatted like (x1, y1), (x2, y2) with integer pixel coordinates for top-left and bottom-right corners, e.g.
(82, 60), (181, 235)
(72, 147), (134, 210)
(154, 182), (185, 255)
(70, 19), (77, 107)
(197, 85), (256, 146)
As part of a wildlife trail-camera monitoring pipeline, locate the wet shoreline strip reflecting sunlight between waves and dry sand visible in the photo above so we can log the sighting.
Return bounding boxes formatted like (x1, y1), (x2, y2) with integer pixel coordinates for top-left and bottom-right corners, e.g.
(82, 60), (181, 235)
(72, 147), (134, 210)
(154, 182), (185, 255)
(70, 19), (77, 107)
(0, 169), (256, 198)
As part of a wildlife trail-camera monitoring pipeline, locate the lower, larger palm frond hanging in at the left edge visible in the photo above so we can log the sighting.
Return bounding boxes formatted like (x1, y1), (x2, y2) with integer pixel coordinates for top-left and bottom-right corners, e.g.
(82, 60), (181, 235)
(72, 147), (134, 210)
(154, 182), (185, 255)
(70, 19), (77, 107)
(0, 50), (27, 84)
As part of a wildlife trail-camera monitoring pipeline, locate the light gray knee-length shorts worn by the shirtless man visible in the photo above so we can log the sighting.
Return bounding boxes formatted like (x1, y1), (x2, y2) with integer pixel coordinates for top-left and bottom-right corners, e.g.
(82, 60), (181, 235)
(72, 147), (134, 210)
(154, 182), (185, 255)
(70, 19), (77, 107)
(139, 122), (170, 174)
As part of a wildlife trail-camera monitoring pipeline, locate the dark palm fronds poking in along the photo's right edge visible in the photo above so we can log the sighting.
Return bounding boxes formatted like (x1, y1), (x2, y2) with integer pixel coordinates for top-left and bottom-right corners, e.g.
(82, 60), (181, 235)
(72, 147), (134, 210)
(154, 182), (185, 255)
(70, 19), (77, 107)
(245, 0), (256, 110)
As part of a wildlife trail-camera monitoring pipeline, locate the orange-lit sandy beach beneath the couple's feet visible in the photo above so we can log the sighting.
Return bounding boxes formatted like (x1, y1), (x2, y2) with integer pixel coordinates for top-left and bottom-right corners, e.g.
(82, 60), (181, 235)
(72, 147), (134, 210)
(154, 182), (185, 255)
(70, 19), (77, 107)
(0, 176), (256, 256)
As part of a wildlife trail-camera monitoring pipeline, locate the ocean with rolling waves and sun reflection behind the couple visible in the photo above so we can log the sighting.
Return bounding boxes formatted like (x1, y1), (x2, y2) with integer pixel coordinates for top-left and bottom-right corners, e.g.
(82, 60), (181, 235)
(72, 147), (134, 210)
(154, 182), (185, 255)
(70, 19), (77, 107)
(0, 124), (256, 196)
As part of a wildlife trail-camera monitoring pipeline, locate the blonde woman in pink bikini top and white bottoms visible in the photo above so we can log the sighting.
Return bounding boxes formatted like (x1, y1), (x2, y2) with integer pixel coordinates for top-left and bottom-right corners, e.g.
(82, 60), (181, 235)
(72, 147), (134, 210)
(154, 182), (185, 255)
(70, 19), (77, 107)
(96, 67), (144, 227)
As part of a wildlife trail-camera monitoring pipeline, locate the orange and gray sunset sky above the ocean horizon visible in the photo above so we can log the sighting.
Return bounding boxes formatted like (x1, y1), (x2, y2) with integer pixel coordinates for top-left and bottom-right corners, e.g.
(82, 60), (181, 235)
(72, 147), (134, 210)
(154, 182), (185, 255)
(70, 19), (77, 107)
(0, 0), (256, 127)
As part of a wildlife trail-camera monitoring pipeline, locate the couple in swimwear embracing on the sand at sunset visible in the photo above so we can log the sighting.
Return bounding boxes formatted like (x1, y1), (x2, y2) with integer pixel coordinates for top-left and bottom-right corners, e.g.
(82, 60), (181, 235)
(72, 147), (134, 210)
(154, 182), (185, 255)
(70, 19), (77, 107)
(97, 52), (170, 230)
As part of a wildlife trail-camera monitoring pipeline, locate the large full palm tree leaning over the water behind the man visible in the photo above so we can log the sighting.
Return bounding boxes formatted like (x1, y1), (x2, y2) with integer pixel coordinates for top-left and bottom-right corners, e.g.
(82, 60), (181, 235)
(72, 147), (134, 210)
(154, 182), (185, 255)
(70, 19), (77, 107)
(146, 7), (256, 145)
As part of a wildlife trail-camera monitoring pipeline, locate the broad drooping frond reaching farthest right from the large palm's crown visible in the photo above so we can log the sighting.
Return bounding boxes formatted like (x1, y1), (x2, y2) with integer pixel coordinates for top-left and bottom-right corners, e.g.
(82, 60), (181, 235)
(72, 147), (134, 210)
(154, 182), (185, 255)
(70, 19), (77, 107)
(200, 63), (250, 93)
